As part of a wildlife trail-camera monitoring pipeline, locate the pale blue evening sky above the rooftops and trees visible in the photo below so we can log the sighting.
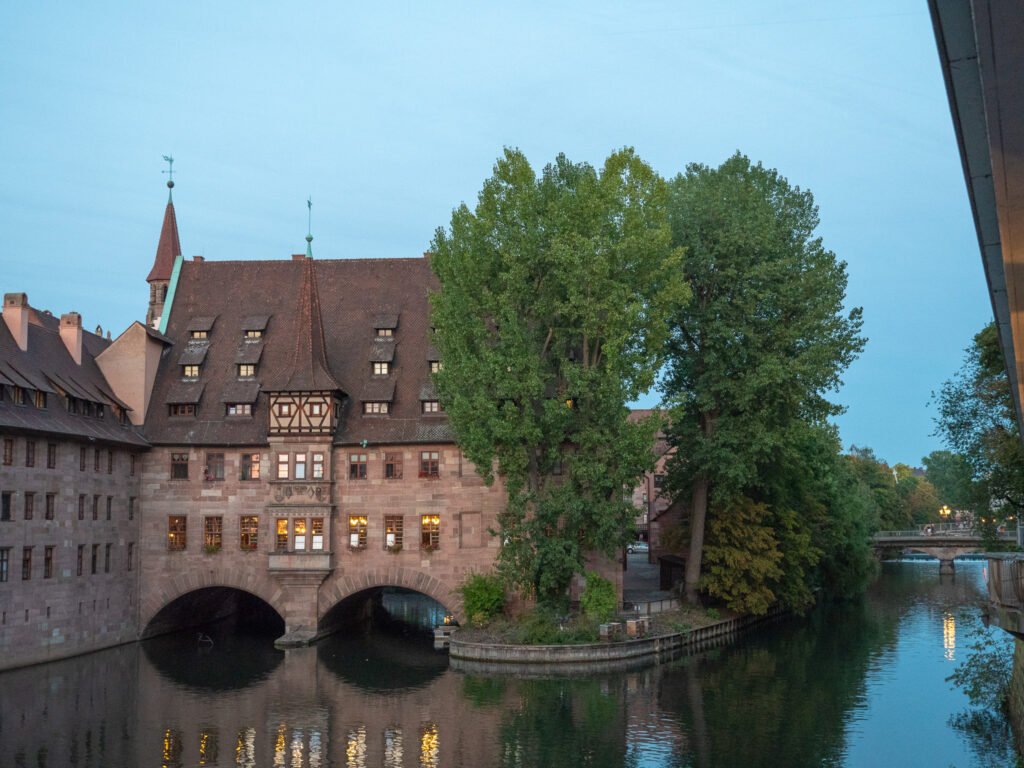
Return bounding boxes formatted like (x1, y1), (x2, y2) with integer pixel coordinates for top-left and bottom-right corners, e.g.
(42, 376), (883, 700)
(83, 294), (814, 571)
(0, 0), (991, 465)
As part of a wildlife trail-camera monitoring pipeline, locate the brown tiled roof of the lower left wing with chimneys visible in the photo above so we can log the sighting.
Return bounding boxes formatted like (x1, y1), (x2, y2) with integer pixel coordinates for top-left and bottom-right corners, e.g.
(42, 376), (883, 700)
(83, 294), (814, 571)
(0, 309), (146, 447)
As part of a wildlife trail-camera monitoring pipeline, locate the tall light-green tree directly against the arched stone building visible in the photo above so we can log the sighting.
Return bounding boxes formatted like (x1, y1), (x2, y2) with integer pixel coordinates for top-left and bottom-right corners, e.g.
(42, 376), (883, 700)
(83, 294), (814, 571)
(431, 150), (685, 603)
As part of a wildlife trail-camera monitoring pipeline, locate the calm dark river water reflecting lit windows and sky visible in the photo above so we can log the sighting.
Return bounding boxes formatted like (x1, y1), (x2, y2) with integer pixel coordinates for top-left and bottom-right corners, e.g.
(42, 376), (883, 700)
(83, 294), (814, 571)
(0, 560), (1013, 768)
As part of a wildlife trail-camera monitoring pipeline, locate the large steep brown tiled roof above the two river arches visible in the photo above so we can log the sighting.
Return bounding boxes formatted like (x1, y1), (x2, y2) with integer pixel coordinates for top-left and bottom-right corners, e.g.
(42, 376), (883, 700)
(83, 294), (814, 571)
(145, 258), (453, 445)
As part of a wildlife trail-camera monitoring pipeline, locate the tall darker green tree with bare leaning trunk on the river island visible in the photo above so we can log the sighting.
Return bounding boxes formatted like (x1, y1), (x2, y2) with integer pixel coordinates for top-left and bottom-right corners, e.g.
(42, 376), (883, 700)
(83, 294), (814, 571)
(663, 153), (865, 601)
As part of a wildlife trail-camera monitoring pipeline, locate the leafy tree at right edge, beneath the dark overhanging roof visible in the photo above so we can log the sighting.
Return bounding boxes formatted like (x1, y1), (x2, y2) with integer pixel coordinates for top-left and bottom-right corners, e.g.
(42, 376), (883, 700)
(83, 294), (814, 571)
(933, 323), (1024, 515)
